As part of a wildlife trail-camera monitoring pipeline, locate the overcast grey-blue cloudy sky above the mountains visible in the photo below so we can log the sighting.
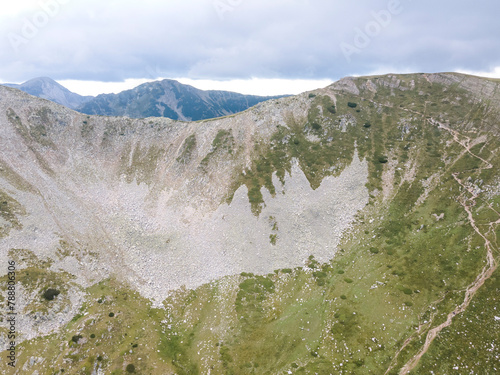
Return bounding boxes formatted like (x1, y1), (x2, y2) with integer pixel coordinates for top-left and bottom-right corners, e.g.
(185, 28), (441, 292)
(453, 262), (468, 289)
(0, 0), (500, 94)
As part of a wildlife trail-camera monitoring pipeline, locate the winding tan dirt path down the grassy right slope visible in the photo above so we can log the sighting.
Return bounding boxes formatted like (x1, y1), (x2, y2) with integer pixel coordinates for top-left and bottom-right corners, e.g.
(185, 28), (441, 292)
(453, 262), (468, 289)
(394, 120), (500, 375)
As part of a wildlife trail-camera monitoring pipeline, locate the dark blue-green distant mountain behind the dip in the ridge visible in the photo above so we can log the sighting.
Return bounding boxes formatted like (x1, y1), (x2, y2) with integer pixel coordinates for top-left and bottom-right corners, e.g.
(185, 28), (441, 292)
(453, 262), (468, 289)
(77, 79), (290, 121)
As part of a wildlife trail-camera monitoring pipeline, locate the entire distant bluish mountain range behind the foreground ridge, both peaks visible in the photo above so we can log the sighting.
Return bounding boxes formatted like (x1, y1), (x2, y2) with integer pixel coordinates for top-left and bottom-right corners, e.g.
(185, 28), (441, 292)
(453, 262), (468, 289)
(4, 77), (286, 121)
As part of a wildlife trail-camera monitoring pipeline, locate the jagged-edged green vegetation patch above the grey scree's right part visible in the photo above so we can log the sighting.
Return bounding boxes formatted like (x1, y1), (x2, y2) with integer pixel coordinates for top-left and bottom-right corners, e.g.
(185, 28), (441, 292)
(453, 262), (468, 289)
(229, 95), (367, 215)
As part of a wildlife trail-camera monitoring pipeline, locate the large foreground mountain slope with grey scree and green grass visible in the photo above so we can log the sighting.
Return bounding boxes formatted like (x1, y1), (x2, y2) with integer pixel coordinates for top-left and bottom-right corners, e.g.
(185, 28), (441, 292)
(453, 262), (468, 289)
(0, 73), (500, 375)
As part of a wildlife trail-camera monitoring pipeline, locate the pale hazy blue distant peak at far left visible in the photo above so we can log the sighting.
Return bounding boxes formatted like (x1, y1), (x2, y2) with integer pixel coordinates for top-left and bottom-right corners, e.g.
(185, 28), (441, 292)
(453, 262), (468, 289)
(3, 77), (92, 109)
